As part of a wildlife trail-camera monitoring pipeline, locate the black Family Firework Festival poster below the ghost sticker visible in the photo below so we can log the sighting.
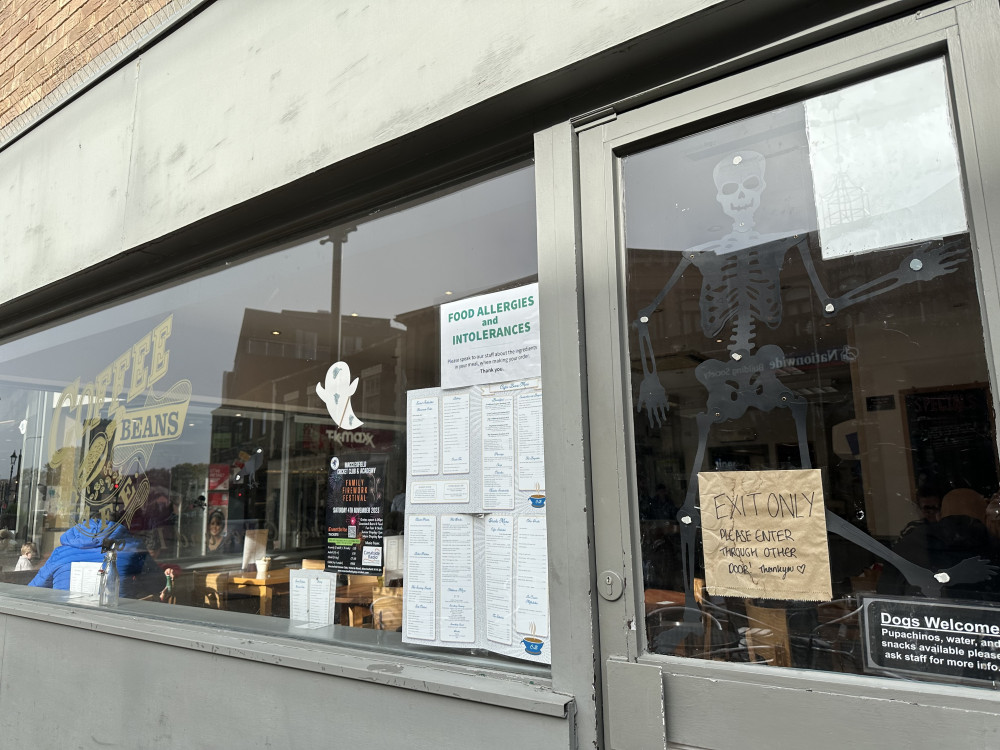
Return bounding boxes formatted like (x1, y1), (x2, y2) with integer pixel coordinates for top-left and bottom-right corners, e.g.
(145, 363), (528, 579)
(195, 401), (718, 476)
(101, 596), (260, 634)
(326, 454), (388, 576)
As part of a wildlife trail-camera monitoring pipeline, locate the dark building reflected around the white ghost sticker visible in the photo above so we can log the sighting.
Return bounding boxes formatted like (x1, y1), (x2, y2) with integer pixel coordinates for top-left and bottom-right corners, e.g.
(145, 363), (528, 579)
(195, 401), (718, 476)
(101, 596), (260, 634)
(210, 308), (414, 549)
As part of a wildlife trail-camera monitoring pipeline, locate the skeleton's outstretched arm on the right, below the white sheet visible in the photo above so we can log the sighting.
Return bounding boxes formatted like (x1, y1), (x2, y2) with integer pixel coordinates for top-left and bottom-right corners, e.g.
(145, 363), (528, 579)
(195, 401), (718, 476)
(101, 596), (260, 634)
(799, 240), (965, 315)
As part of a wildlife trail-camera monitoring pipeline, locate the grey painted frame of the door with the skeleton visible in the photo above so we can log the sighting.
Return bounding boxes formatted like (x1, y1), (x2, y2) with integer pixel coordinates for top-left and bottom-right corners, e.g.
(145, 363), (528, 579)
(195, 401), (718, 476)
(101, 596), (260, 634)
(560, 0), (1000, 748)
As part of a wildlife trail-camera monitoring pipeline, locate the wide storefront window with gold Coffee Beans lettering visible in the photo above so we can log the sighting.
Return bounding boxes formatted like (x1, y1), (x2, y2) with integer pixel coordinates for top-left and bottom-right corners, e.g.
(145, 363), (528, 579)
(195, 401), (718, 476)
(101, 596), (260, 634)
(0, 166), (547, 676)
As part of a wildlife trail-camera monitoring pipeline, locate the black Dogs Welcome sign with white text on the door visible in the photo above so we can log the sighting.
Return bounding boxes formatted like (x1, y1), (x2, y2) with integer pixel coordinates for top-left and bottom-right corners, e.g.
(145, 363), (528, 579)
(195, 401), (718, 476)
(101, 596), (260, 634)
(861, 596), (1000, 683)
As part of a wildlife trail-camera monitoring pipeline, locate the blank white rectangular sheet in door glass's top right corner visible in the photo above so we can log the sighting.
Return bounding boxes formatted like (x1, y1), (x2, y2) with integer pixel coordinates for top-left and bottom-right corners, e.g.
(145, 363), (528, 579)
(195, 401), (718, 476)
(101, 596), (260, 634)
(806, 60), (966, 258)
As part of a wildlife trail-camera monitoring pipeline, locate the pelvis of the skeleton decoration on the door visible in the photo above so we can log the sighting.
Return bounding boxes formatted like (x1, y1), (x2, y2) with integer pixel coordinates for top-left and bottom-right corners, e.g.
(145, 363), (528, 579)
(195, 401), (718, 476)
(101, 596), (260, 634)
(694, 344), (803, 423)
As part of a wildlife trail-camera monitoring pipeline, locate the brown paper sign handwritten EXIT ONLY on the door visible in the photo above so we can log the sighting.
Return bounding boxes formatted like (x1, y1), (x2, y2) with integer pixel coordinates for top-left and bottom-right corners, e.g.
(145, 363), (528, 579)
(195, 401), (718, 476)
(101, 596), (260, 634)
(698, 469), (832, 601)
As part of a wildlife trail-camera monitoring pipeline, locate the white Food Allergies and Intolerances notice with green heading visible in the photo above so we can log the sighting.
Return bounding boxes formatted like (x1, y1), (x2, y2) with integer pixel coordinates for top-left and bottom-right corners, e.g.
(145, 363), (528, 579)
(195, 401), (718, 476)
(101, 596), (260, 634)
(441, 284), (542, 389)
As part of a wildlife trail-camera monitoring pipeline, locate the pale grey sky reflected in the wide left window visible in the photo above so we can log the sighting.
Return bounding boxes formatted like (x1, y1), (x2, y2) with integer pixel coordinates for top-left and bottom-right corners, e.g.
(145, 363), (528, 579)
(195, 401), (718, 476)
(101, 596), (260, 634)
(0, 167), (538, 465)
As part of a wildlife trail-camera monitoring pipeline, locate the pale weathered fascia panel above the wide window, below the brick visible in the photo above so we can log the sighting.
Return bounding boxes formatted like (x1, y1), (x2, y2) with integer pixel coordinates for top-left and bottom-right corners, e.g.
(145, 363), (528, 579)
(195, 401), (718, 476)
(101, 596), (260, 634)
(0, 0), (717, 304)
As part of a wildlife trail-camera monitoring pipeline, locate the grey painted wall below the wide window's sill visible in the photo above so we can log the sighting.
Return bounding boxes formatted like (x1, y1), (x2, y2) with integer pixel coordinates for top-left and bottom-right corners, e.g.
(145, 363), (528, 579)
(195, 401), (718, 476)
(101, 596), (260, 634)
(0, 615), (572, 750)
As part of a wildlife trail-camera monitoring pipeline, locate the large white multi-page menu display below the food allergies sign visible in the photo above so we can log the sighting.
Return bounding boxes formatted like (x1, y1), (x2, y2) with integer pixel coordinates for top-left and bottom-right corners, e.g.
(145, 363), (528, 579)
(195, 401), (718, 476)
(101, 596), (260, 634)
(403, 378), (551, 664)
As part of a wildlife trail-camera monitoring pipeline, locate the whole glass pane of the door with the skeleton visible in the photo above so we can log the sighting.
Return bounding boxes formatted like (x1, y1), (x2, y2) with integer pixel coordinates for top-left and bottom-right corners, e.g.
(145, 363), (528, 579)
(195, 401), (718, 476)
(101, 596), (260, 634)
(623, 60), (1000, 684)
